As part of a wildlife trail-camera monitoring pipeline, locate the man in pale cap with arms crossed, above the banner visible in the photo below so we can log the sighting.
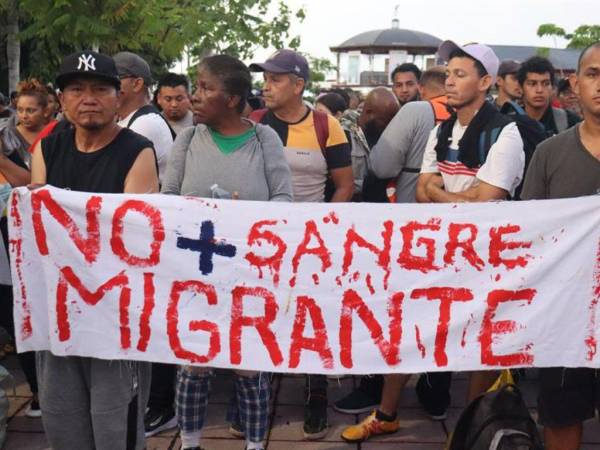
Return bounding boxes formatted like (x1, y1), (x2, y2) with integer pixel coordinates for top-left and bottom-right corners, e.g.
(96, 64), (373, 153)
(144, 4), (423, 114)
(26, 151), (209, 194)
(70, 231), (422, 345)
(417, 41), (525, 401)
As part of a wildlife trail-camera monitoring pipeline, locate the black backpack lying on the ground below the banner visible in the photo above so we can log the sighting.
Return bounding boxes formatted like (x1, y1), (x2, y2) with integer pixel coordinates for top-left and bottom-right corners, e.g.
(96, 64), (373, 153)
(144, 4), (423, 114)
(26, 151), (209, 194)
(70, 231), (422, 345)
(448, 384), (544, 450)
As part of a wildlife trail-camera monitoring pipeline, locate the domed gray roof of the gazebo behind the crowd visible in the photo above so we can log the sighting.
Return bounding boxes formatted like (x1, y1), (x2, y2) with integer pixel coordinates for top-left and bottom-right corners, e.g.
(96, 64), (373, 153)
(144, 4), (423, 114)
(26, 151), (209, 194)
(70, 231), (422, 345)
(331, 28), (442, 54)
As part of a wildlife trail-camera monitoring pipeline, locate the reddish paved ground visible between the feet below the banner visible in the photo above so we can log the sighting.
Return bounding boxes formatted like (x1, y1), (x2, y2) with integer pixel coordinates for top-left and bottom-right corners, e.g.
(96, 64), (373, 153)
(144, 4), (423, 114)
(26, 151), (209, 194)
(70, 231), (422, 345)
(1, 357), (600, 450)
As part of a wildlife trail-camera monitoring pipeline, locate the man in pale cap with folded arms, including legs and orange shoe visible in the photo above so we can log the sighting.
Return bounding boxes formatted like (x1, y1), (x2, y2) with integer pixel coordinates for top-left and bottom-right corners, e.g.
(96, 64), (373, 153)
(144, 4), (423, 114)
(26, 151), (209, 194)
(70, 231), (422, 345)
(342, 41), (525, 442)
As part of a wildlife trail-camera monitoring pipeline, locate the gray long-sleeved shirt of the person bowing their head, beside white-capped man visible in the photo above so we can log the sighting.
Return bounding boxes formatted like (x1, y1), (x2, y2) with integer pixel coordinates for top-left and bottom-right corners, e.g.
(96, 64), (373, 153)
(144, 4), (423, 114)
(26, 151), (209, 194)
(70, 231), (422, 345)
(369, 102), (435, 203)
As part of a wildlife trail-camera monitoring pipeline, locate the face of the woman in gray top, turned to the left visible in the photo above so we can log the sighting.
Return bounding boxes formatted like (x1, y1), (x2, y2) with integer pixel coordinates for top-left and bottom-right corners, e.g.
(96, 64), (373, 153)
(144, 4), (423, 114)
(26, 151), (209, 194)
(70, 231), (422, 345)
(192, 68), (232, 126)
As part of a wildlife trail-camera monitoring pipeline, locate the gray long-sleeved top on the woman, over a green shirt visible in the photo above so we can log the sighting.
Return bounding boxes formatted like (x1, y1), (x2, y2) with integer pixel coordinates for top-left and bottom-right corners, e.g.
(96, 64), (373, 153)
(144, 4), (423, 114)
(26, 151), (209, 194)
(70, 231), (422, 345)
(161, 125), (292, 202)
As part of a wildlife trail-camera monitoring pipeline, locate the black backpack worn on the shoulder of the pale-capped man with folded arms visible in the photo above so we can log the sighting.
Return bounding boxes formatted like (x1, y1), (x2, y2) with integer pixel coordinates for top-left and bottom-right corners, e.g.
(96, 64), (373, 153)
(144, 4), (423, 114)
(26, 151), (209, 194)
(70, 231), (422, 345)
(478, 101), (547, 200)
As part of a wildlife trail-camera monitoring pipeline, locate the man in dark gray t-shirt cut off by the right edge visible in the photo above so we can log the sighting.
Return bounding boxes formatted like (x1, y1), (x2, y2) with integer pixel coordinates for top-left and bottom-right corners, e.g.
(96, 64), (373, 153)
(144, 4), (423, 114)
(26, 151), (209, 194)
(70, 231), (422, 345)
(522, 43), (600, 450)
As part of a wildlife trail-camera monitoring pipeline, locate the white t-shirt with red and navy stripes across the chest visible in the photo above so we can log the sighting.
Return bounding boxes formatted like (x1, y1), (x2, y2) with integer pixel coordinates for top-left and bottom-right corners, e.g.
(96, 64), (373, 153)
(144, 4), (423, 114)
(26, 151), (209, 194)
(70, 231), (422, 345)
(421, 120), (525, 195)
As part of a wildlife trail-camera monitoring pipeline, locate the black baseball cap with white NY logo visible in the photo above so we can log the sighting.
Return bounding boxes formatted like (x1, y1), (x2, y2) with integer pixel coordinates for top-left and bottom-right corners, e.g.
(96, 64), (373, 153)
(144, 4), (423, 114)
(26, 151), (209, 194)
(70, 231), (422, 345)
(56, 50), (121, 91)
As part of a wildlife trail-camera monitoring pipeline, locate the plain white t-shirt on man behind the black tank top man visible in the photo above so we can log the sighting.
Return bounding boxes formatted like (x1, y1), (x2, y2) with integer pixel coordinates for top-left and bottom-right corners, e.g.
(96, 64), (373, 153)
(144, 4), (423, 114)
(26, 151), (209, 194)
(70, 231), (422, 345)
(119, 111), (173, 181)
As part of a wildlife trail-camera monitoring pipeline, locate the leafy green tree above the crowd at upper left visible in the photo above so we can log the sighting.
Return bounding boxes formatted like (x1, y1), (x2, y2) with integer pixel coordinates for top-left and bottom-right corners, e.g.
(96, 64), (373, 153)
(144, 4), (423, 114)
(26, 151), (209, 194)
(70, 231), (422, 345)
(0, 0), (304, 90)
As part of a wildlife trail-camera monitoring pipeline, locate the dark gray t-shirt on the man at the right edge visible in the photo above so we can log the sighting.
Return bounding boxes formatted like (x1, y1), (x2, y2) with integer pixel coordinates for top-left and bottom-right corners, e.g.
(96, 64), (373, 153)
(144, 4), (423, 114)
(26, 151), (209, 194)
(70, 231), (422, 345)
(521, 125), (600, 200)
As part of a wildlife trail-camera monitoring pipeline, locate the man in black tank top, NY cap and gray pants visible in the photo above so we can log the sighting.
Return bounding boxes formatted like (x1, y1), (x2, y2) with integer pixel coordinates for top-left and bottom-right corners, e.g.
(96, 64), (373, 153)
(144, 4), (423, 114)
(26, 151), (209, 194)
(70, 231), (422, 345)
(31, 51), (158, 450)
